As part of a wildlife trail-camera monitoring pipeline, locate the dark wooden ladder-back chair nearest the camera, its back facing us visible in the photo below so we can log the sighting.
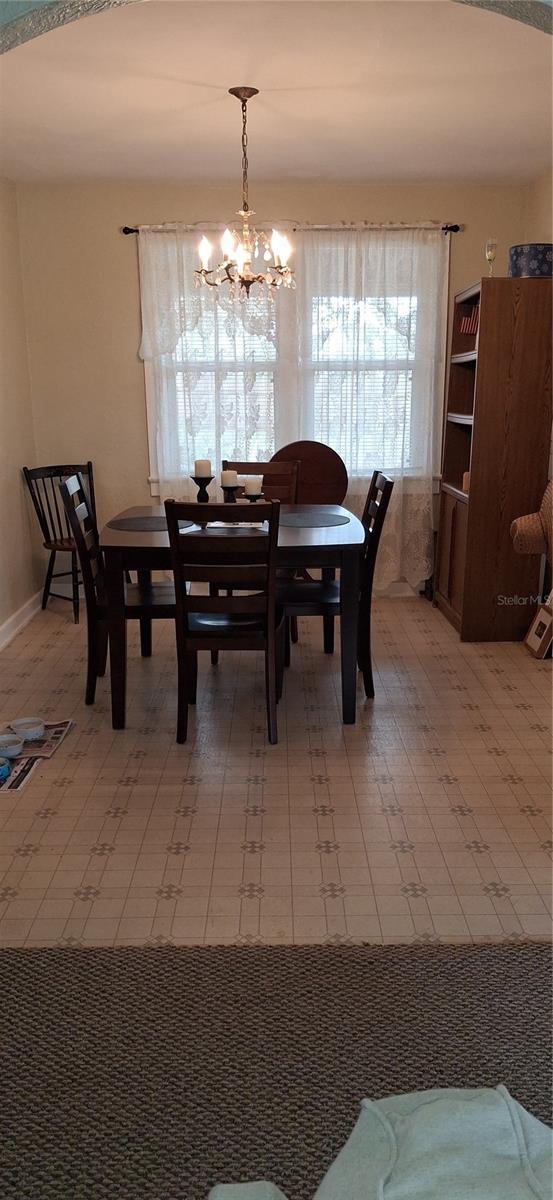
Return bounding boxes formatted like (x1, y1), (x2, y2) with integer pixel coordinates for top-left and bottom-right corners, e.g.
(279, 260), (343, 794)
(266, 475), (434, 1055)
(166, 500), (284, 743)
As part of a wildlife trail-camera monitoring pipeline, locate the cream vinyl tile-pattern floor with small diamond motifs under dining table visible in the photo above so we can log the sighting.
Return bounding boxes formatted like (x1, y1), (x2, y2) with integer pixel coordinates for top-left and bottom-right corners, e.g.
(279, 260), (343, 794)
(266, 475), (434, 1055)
(0, 598), (552, 946)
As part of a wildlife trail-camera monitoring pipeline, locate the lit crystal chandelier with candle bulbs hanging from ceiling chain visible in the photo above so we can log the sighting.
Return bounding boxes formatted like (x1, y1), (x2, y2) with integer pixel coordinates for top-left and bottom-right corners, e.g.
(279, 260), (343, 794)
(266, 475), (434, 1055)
(194, 88), (295, 300)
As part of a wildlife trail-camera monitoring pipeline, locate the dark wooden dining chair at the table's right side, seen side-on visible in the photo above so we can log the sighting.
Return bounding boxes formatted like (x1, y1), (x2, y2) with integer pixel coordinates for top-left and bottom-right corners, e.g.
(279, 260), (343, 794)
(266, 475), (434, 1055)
(277, 470), (393, 697)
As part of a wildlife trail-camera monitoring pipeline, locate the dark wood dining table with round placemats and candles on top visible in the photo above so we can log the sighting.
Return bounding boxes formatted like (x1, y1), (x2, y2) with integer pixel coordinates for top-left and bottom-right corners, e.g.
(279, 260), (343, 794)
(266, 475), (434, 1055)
(100, 504), (365, 730)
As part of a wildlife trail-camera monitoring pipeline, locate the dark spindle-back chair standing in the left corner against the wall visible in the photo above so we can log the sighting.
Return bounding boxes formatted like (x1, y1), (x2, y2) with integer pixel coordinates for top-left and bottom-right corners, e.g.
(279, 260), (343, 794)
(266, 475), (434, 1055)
(23, 462), (96, 624)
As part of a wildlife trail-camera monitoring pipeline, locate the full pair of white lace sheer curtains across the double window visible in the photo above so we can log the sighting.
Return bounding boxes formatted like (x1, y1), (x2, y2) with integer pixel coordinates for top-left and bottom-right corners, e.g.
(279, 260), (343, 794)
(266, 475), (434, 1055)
(139, 228), (449, 588)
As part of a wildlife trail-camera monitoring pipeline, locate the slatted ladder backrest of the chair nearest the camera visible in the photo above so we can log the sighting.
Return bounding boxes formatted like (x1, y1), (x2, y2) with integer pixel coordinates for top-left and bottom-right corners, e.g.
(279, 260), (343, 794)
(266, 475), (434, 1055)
(161, 500), (281, 631)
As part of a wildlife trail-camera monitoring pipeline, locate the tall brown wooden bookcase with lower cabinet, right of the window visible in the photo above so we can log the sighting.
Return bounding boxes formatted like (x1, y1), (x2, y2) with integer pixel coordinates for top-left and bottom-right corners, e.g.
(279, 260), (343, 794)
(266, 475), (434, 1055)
(434, 278), (552, 642)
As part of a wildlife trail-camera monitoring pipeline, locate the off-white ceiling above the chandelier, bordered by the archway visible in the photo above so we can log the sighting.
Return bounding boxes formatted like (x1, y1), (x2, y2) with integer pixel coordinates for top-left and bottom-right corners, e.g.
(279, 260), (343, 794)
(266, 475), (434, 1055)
(0, 0), (552, 182)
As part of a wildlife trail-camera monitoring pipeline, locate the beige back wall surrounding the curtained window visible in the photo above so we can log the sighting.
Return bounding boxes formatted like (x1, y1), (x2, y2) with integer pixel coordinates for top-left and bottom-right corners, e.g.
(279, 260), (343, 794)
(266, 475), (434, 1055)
(18, 180), (525, 521)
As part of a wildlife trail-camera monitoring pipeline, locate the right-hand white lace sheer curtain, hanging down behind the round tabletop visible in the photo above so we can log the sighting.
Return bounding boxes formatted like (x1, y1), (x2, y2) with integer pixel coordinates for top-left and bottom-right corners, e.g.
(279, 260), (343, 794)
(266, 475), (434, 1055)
(296, 229), (449, 589)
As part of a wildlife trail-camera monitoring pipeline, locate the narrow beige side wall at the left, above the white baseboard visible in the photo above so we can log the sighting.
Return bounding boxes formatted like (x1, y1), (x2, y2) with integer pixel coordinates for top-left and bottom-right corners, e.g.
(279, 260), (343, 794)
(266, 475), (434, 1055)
(0, 180), (40, 636)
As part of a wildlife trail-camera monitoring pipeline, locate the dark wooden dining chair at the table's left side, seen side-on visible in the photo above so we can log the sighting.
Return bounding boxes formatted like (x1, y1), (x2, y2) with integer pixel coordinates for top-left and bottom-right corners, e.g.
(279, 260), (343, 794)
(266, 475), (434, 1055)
(60, 474), (175, 704)
